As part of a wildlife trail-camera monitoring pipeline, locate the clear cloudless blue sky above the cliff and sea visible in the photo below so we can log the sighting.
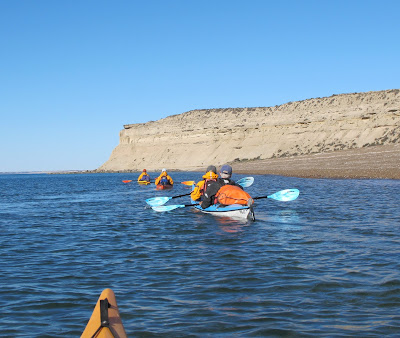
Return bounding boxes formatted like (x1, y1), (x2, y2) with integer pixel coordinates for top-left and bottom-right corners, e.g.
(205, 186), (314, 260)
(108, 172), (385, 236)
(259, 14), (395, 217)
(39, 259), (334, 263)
(0, 0), (400, 172)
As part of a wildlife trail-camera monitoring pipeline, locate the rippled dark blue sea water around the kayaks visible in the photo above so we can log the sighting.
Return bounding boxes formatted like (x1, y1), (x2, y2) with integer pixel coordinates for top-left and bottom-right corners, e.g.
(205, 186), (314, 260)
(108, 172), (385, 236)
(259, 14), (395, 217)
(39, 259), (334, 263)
(0, 173), (400, 337)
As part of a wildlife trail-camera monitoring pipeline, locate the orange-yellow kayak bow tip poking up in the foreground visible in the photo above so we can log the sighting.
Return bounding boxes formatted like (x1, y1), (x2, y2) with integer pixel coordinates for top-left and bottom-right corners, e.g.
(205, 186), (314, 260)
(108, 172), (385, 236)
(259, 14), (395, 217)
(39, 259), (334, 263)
(81, 289), (127, 338)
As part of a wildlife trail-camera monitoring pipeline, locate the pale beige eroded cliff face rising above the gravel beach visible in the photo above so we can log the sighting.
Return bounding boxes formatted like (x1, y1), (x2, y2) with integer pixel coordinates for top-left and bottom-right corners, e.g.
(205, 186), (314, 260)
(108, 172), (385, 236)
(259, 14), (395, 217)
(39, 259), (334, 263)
(98, 89), (400, 171)
